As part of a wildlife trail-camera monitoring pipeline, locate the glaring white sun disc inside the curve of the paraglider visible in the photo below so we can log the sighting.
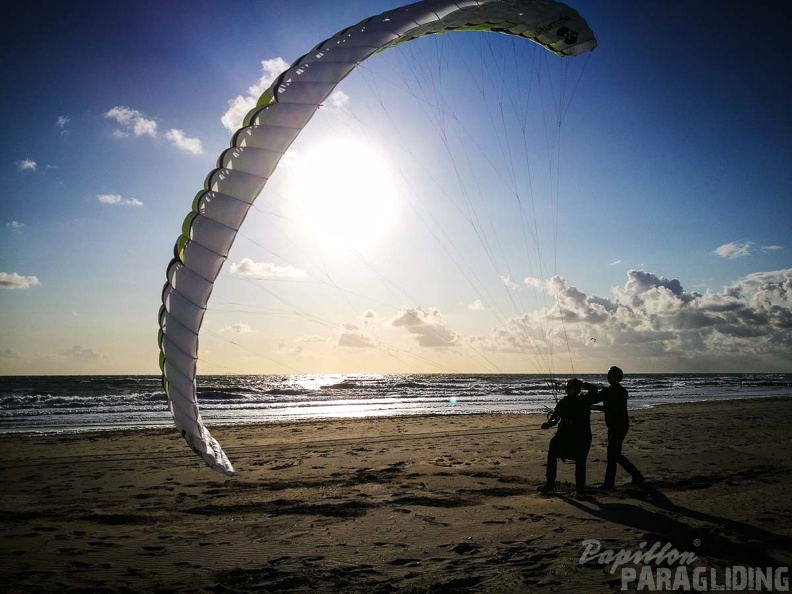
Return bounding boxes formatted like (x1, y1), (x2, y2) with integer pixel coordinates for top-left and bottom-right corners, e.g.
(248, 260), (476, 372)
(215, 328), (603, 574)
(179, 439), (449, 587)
(292, 139), (396, 247)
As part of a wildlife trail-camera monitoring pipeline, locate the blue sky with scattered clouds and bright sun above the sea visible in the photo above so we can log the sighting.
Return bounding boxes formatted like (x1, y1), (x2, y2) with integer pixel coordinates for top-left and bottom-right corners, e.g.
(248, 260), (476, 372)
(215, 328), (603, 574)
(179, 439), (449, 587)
(0, 0), (792, 375)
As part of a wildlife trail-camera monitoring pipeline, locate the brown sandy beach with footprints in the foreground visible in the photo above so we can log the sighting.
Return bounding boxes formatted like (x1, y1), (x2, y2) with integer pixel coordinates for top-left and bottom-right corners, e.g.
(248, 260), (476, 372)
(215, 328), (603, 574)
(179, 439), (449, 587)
(0, 398), (792, 594)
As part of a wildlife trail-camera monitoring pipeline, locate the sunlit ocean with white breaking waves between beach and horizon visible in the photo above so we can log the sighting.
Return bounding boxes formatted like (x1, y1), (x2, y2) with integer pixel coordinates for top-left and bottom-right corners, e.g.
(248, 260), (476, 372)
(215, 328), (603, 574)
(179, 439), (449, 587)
(0, 374), (792, 433)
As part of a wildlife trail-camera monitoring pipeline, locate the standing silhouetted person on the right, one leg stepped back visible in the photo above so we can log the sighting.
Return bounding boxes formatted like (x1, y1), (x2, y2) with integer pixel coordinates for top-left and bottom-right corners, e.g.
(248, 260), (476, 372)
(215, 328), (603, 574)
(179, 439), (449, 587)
(584, 367), (645, 489)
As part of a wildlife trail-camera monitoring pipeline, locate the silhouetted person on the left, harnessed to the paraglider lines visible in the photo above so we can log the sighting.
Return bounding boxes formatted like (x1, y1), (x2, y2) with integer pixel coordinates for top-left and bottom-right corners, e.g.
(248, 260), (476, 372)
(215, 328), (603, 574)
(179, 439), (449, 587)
(539, 378), (597, 495)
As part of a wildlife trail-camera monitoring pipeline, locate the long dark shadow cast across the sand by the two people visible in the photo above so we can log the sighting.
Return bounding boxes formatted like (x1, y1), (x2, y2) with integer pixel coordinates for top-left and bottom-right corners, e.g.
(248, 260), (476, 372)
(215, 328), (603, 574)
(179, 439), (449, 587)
(561, 485), (792, 568)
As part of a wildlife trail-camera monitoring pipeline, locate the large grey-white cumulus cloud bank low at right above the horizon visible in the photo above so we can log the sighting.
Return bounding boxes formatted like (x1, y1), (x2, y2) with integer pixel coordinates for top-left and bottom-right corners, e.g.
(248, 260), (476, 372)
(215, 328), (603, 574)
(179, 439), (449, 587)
(502, 269), (792, 371)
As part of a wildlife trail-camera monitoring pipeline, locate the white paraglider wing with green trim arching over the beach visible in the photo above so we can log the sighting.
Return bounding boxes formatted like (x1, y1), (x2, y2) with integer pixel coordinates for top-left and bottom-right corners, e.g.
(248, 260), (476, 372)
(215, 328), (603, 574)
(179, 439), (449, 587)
(159, 0), (596, 476)
